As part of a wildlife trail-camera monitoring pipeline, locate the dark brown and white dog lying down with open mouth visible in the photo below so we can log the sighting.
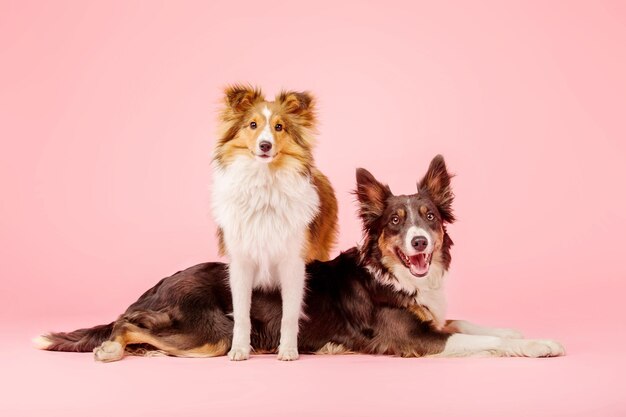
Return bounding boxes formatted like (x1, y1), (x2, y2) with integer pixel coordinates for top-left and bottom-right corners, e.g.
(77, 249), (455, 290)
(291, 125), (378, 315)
(38, 156), (564, 362)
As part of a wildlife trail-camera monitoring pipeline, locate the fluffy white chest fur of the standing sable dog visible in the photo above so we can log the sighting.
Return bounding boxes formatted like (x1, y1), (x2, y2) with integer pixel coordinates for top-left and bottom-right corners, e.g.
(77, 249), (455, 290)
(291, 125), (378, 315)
(212, 157), (320, 285)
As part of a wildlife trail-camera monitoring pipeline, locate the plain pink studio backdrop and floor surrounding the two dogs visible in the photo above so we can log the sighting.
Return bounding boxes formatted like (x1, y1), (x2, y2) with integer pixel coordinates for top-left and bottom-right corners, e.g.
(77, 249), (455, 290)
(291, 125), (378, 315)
(0, 1), (626, 416)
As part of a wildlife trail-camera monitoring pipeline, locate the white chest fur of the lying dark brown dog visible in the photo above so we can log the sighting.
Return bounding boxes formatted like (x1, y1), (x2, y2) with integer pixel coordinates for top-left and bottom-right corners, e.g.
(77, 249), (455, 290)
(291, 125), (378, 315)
(392, 265), (448, 328)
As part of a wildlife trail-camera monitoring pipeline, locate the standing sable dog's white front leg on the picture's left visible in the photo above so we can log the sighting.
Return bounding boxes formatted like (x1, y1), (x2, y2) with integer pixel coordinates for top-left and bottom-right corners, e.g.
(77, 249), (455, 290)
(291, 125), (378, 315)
(228, 257), (255, 361)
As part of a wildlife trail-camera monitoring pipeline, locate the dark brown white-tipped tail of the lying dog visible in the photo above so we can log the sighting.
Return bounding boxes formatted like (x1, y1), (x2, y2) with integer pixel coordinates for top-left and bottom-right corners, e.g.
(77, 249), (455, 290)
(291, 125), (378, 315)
(33, 322), (115, 352)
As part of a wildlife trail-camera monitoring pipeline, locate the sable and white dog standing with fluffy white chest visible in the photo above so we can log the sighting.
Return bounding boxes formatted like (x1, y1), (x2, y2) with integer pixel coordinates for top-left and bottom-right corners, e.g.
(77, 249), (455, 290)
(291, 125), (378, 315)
(212, 85), (337, 360)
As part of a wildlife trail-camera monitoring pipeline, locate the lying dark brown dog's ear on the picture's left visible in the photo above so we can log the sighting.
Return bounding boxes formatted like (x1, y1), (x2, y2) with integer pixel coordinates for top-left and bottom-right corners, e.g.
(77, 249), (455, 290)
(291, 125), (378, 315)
(354, 168), (393, 227)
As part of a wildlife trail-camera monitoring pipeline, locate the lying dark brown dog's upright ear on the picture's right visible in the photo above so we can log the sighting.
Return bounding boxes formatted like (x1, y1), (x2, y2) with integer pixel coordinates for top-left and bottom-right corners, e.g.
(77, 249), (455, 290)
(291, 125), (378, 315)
(417, 155), (454, 223)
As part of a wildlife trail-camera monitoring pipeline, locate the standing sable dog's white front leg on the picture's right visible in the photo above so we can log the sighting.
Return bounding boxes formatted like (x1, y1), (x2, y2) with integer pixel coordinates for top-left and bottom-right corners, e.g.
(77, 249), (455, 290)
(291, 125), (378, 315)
(278, 255), (305, 361)
